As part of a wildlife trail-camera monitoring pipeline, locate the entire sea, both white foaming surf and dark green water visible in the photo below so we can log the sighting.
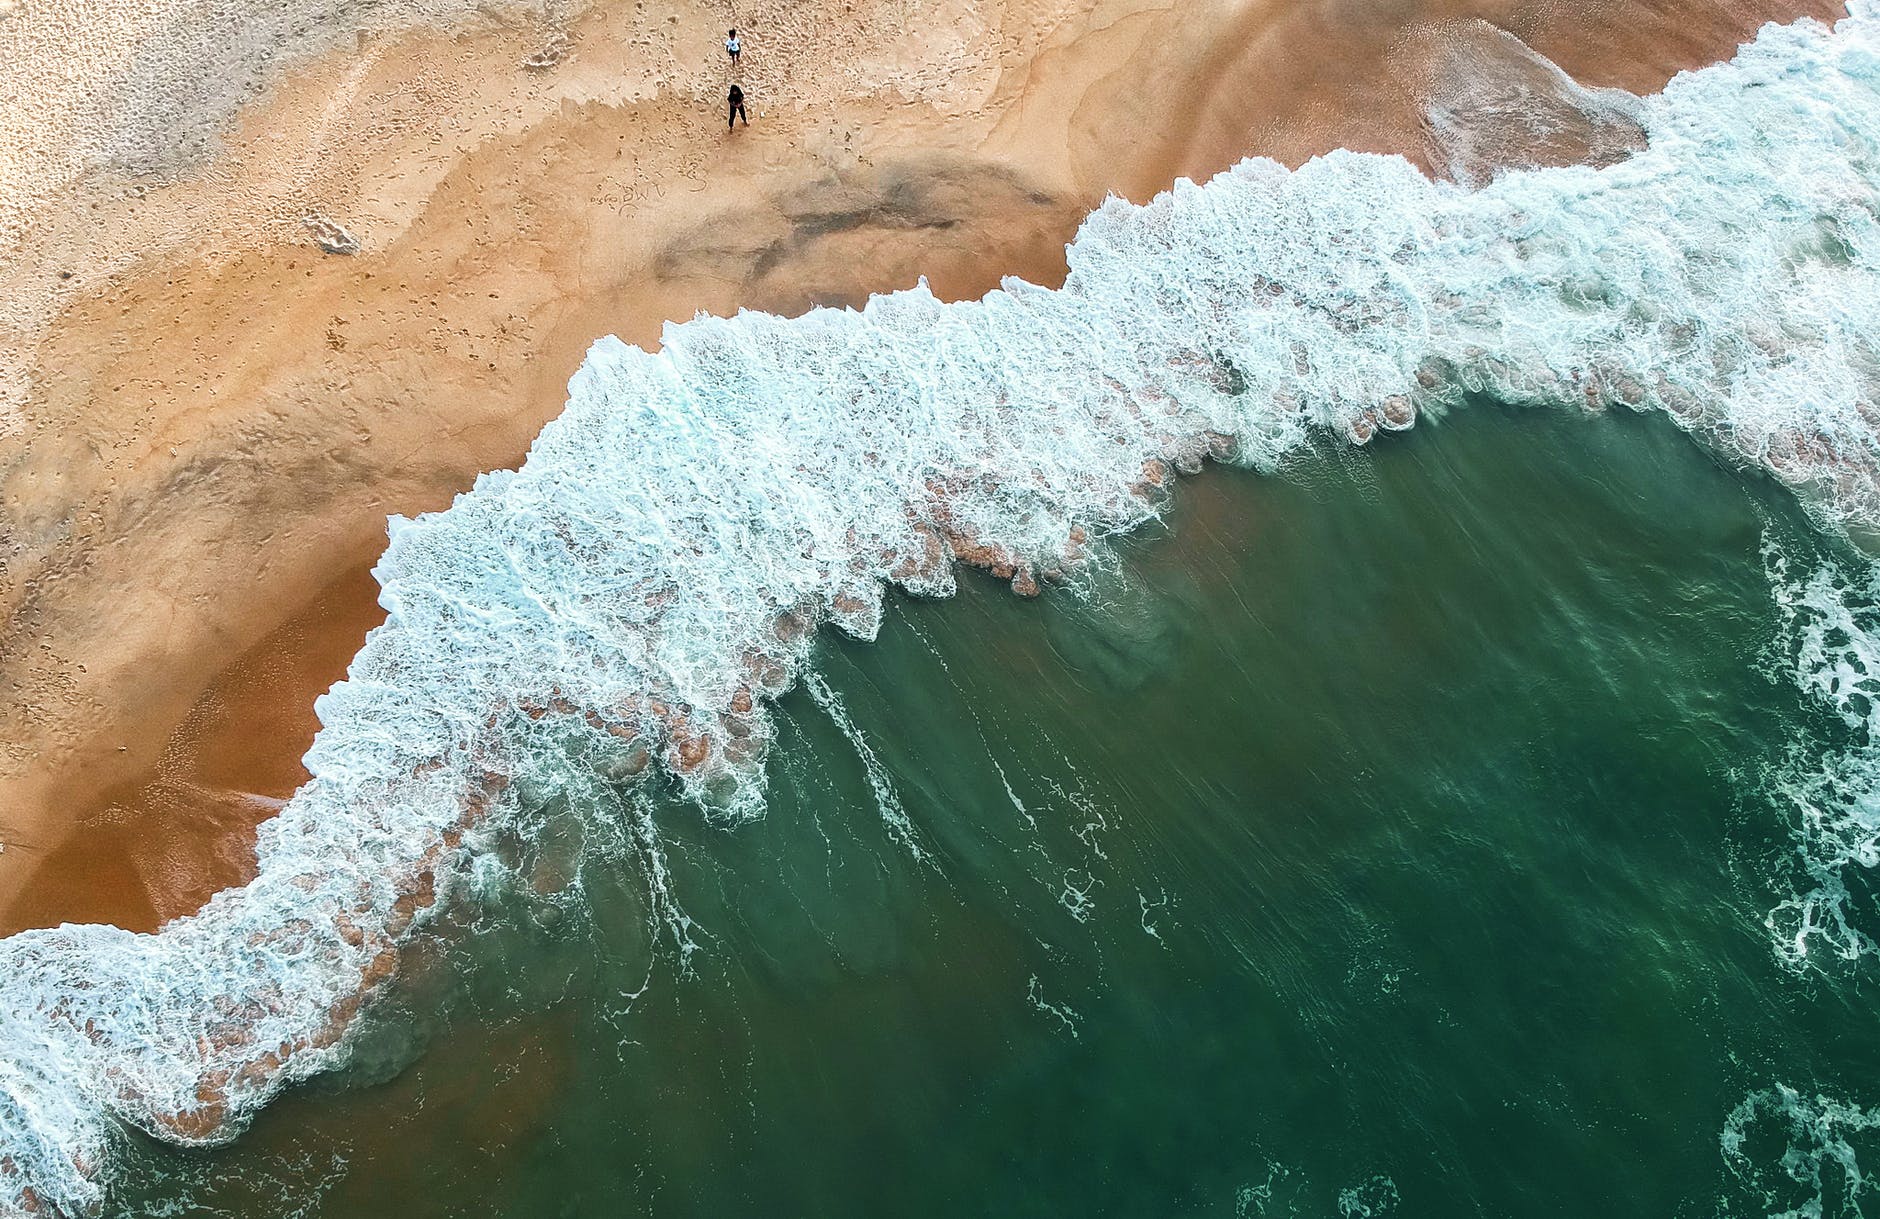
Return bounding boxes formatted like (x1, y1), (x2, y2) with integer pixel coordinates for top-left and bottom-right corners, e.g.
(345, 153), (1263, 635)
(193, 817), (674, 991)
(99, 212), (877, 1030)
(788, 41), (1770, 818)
(0, 6), (1880, 1215)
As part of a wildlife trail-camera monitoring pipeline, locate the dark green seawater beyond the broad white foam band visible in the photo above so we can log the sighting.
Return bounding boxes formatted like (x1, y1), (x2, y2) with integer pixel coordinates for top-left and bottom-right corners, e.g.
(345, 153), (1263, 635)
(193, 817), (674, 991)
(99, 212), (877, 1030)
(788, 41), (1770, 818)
(115, 404), (1880, 1219)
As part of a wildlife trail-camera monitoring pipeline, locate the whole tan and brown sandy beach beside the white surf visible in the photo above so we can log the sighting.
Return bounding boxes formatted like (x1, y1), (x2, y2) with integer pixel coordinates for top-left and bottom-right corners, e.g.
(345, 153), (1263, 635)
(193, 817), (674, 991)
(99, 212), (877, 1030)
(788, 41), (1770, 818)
(0, 0), (1839, 933)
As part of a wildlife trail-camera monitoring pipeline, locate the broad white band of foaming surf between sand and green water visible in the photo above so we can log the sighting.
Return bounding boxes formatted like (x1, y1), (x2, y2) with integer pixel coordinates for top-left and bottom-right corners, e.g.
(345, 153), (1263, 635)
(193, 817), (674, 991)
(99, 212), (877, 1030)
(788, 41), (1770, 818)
(11, 8), (1880, 1211)
